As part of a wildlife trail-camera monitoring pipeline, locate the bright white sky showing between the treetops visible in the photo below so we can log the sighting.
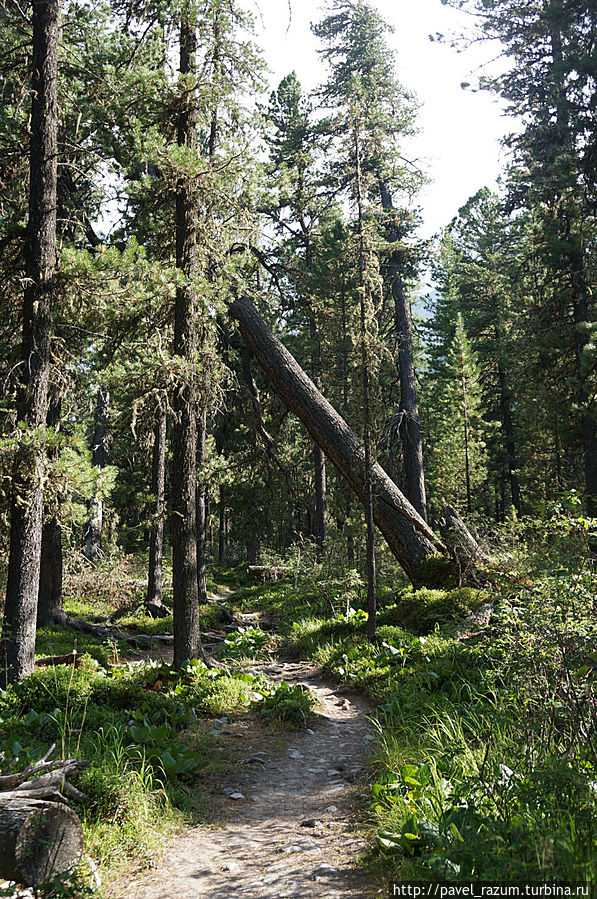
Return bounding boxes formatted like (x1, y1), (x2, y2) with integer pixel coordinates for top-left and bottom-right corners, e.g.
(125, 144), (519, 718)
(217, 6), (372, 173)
(247, 0), (512, 237)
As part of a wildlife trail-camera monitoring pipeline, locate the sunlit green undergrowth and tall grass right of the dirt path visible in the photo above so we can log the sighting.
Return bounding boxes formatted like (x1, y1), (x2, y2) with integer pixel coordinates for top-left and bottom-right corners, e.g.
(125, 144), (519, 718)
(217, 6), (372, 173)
(218, 515), (597, 882)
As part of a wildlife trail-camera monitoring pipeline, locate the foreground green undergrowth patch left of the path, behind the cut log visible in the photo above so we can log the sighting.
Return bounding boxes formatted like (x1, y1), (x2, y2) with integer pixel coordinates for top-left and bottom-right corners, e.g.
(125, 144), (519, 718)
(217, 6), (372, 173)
(0, 655), (293, 895)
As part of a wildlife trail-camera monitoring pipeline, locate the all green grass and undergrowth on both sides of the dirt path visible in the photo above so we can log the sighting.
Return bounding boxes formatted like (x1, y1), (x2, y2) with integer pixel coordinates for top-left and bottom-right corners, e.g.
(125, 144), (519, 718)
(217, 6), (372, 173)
(0, 519), (597, 895)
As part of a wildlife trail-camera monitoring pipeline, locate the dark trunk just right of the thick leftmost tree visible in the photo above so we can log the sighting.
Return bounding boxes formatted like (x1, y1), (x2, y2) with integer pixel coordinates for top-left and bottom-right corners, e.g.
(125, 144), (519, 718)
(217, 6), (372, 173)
(37, 383), (65, 627)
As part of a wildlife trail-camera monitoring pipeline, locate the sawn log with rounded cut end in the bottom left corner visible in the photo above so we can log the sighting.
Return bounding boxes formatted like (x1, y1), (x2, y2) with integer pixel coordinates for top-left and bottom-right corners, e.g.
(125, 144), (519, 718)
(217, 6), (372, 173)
(0, 794), (84, 886)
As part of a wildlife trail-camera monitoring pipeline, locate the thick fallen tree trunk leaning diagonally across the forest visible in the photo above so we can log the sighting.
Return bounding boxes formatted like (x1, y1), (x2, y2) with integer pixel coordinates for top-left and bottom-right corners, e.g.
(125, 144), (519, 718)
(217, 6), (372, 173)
(229, 297), (453, 586)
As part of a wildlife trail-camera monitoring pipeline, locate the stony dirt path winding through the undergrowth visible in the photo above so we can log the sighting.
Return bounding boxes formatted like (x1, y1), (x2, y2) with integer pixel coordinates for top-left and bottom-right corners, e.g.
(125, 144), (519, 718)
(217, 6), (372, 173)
(109, 663), (376, 899)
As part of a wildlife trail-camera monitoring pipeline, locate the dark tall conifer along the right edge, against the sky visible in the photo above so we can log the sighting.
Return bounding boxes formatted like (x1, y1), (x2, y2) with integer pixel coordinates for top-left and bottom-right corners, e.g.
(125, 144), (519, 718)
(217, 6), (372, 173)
(448, 0), (597, 515)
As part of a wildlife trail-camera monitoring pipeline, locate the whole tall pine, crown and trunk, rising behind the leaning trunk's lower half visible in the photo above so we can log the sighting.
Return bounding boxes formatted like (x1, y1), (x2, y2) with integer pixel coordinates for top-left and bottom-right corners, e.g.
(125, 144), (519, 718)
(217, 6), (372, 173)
(314, 0), (426, 518)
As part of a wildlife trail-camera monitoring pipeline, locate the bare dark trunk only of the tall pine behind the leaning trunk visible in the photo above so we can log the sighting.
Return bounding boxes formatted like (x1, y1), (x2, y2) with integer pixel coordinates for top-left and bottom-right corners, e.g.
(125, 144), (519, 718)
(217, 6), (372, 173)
(379, 180), (427, 521)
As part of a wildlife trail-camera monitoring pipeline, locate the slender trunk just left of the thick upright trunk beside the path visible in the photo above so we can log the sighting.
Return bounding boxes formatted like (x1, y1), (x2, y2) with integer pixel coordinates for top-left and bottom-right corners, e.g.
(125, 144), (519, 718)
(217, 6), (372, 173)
(146, 394), (167, 606)
